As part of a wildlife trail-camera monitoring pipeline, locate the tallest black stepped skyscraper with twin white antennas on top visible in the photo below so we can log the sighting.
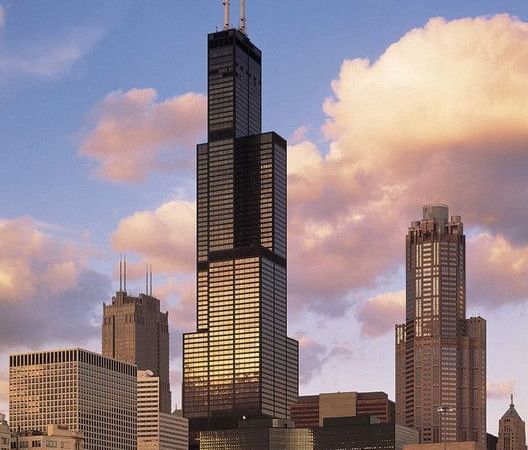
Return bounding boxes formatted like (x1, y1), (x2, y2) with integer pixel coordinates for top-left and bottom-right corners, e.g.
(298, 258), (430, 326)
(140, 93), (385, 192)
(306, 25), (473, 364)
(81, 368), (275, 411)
(183, 2), (298, 446)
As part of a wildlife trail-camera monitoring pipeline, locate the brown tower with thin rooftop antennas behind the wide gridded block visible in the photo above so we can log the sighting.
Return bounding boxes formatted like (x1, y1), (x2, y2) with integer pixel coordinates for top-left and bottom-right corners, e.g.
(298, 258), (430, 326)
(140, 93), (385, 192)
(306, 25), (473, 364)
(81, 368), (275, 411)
(102, 288), (171, 413)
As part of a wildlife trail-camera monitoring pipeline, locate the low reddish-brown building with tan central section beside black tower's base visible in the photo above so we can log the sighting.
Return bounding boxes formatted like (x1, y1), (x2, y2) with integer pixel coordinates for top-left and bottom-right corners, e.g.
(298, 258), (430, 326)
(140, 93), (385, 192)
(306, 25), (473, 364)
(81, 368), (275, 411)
(291, 392), (395, 428)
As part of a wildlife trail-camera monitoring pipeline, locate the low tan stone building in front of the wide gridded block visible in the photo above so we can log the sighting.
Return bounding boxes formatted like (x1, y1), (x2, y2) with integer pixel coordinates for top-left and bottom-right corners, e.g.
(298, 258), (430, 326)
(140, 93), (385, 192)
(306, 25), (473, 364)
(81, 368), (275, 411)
(11, 425), (85, 450)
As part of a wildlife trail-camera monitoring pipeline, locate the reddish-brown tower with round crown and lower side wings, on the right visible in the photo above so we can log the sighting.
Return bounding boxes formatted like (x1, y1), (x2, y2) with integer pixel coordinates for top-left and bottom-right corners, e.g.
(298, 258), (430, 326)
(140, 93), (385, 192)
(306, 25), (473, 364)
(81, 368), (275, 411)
(396, 205), (486, 445)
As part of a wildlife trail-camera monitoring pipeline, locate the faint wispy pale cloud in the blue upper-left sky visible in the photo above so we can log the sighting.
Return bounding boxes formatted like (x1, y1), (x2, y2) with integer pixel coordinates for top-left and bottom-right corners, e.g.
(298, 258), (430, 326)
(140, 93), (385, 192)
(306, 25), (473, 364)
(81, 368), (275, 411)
(0, 25), (104, 81)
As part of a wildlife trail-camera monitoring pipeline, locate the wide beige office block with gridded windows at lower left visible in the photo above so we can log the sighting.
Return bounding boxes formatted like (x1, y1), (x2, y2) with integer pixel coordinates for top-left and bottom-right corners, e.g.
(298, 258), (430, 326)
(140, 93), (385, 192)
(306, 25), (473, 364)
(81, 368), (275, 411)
(9, 348), (137, 450)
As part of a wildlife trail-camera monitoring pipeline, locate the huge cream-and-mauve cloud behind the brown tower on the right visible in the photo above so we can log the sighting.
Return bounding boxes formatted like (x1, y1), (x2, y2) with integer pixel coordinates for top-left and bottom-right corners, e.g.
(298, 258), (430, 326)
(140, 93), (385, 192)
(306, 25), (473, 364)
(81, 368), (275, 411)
(288, 15), (528, 316)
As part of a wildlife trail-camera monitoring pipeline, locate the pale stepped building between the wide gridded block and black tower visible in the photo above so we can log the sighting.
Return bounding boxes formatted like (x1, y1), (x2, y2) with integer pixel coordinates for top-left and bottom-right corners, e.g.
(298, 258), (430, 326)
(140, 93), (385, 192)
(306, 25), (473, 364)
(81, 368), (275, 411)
(137, 371), (189, 450)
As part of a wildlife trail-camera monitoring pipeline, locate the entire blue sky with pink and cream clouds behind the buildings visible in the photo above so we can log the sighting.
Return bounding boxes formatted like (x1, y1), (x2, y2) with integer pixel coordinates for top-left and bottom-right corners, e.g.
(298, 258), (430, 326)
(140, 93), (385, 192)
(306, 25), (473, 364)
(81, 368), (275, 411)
(0, 0), (528, 432)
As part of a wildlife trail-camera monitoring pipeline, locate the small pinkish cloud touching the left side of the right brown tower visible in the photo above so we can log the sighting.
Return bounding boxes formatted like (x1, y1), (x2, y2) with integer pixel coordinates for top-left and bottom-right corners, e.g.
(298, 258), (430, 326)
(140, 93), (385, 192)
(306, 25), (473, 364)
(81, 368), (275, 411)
(355, 290), (405, 337)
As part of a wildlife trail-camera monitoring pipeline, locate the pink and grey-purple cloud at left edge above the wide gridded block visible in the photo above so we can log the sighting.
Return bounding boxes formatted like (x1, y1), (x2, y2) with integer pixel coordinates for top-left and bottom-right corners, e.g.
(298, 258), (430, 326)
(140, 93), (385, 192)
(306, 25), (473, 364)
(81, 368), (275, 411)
(0, 218), (111, 352)
